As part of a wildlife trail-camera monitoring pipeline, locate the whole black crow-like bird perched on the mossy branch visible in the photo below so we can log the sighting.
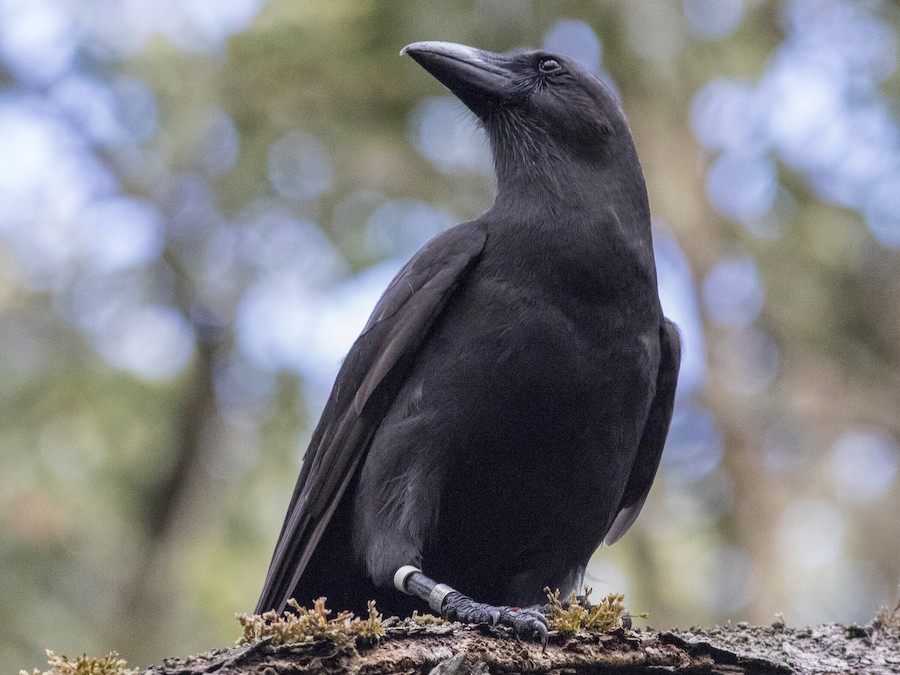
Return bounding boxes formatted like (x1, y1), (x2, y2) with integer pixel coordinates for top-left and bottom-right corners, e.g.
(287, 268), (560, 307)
(256, 42), (680, 639)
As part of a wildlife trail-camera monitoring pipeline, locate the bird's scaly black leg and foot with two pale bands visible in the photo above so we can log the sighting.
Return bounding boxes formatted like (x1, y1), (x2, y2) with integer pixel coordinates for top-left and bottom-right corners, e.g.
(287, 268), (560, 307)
(394, 565), (547, 647)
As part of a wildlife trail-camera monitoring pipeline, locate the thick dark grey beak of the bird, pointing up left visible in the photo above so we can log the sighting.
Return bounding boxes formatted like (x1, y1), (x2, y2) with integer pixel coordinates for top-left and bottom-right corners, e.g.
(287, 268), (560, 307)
(400, 42), (513, 117)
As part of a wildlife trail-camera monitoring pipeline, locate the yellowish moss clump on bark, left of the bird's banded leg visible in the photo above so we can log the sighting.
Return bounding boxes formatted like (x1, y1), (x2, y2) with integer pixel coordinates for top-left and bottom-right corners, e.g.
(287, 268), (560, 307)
(236, 598), (384, 645)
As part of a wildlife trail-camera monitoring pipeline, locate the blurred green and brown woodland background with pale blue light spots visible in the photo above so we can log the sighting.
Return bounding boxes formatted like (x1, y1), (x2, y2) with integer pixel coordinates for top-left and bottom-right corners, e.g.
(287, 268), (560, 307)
(0, 0), (900, 672)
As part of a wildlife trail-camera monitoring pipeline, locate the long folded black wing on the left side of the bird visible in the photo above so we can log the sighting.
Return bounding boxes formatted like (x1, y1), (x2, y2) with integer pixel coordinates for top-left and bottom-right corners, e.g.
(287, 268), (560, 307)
(256, 221), (487, 613)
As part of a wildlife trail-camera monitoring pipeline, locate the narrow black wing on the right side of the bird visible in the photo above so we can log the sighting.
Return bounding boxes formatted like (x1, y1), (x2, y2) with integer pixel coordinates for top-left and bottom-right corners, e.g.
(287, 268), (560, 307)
(604, 319), (681, 544)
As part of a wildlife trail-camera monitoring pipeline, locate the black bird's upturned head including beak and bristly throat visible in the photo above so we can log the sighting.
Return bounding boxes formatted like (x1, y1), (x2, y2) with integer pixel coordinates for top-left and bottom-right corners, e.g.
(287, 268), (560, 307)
(401, 42), (642, 202)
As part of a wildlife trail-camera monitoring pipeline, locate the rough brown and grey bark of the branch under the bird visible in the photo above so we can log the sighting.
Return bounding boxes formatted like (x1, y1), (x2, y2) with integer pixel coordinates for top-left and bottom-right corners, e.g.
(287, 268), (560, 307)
(145, 619), (900, 675)
